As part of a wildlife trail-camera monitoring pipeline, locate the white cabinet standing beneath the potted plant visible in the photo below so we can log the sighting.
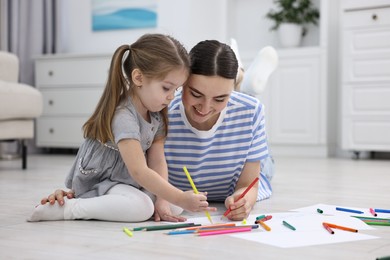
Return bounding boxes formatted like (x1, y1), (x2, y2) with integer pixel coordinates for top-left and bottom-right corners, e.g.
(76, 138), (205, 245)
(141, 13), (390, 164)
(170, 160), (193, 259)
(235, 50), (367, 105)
(260, 47), (327, 156)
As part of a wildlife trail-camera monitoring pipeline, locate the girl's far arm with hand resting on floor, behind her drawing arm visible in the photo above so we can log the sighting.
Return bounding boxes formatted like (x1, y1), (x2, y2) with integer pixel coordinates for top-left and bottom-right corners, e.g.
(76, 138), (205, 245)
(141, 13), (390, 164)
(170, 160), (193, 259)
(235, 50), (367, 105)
(147, 139), (186, 222)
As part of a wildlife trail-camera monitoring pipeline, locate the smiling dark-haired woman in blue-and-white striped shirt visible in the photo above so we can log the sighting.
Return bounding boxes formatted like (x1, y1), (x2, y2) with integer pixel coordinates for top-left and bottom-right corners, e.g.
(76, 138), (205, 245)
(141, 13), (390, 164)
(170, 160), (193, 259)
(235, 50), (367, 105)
(164, 40), (273, 220)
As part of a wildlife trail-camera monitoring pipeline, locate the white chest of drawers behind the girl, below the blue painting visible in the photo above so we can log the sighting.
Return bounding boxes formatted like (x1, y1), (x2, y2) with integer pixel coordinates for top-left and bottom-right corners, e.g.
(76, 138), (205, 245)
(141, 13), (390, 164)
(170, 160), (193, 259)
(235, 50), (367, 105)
(35, 54), (111, 148)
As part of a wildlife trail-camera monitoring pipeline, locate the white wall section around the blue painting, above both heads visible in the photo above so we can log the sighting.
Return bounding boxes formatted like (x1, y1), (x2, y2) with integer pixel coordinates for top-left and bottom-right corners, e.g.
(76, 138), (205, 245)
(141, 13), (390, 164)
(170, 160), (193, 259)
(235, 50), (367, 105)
(62, 0), (228, 53)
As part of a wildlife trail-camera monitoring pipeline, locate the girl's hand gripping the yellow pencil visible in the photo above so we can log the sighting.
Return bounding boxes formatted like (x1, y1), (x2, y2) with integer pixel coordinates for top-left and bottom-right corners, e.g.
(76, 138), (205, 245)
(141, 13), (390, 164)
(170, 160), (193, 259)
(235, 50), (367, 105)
(178, 191), (217, 212)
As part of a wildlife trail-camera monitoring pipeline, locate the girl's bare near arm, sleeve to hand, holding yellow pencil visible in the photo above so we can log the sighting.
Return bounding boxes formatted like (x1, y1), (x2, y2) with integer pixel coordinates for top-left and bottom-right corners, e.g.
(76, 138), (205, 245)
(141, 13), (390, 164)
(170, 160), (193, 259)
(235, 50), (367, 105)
(118, 139), (209, 211)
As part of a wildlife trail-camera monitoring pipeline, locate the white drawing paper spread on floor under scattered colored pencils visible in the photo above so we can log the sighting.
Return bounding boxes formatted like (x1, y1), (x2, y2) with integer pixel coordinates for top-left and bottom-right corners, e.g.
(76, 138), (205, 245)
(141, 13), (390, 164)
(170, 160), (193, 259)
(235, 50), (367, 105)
(184, 209), (378, 248)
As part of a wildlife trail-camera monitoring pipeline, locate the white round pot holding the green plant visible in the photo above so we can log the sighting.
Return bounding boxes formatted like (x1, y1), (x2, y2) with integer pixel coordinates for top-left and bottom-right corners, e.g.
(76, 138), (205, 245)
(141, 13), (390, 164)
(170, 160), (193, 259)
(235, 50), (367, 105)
(278, 23), (303, 48)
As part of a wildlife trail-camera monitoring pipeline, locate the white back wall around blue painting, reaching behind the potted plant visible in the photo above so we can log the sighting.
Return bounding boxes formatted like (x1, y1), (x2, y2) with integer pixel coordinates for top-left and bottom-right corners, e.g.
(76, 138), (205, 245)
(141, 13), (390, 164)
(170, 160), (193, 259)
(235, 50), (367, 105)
(61, 0), (319, 57)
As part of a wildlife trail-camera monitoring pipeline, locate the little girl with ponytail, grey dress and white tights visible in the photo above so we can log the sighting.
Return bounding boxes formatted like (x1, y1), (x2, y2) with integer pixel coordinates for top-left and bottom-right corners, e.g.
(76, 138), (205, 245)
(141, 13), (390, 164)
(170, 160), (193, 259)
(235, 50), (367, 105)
(28, 34), (215, 222)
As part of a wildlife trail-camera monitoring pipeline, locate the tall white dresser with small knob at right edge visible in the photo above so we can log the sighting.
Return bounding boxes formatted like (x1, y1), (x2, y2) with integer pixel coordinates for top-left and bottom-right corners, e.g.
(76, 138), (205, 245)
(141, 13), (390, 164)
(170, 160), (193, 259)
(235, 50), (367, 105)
(341, 0), (390, 154)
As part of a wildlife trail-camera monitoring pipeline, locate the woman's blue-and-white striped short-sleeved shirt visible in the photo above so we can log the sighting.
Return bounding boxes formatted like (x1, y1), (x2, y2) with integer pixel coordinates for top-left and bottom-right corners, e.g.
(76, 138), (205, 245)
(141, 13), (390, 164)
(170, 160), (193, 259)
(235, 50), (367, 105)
(165, 92), (272, 201)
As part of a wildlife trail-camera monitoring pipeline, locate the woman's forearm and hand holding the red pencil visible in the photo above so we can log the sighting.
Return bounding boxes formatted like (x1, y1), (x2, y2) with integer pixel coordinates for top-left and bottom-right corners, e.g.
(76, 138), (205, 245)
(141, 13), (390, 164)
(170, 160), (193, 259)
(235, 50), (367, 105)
(225, 161), (260, 220)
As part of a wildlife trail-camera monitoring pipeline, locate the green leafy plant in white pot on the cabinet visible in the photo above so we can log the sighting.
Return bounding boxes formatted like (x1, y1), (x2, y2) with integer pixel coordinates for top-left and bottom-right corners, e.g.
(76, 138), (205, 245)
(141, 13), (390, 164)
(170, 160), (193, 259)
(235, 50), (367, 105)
(266, 0), (320, 47)
